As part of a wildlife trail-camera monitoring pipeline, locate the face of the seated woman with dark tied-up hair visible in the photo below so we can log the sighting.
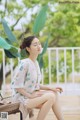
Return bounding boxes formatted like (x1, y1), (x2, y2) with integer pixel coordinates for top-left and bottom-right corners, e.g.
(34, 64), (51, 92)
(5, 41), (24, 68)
(27, 38), (42, 55)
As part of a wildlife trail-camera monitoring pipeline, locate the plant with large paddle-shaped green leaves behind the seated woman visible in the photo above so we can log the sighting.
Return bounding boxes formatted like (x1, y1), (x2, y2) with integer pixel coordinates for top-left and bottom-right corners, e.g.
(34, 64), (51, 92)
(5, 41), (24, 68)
(0, 5), (49, 68)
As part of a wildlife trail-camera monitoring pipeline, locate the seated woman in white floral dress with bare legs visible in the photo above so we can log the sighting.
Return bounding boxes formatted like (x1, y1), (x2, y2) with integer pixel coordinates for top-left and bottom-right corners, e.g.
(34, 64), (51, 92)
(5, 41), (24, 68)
(12, 36), (63, 120)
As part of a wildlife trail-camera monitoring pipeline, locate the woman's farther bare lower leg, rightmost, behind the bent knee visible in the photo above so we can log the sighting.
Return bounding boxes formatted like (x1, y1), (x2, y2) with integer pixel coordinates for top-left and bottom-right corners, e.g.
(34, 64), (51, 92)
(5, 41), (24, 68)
(52, 93), (63, 120)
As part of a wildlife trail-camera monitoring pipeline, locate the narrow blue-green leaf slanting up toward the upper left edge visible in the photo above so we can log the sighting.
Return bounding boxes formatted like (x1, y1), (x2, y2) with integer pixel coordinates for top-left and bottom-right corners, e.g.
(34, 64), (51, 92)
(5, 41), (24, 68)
(2, 19), (17, 44)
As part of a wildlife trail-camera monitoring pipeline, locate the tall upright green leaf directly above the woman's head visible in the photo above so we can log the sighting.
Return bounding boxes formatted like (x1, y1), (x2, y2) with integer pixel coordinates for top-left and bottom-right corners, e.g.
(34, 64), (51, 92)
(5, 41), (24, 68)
(33, 5), (48, 34)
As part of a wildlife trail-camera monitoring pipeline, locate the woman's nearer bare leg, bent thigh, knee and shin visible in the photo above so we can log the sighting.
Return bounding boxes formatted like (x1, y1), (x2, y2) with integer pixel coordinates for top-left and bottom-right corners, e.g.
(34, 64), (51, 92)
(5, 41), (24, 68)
(27, 93), (55, 120)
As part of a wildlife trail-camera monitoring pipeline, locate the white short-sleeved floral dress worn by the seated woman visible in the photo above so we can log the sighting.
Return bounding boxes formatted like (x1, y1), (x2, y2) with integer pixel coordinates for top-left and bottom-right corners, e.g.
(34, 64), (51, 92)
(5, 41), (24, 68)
(12, 58), (41, 103)
